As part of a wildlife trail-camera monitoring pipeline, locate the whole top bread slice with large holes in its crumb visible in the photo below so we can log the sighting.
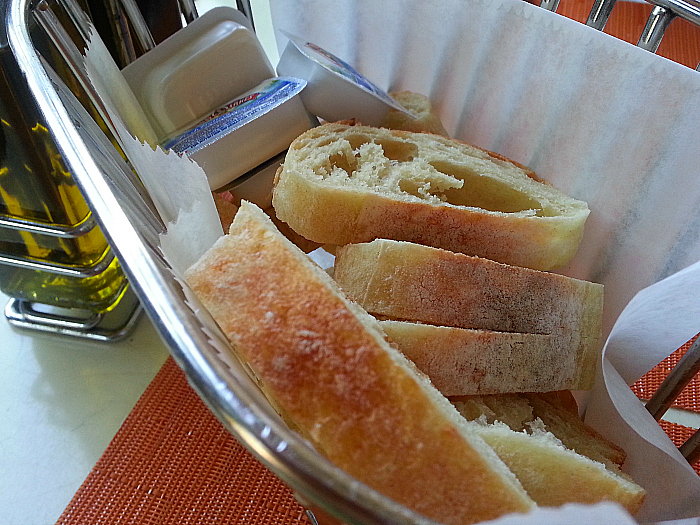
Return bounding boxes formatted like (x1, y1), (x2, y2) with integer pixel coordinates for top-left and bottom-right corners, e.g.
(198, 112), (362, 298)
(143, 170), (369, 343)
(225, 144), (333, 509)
(272, 124), (589, 270)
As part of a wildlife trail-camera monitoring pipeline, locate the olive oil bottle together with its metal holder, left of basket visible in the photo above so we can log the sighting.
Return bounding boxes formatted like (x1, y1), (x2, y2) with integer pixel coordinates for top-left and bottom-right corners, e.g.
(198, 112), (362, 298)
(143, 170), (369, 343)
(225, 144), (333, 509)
(0, 0), (157, 341)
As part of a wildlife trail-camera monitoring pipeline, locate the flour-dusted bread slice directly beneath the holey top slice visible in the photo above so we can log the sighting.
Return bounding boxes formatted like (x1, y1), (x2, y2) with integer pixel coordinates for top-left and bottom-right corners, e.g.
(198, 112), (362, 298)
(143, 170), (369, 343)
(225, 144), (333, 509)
(334, 239), (603, 391)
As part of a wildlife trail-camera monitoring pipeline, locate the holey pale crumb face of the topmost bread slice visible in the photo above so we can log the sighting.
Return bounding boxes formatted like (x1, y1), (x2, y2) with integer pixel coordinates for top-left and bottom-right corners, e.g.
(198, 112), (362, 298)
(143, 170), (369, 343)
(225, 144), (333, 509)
(293, 124), (573, 217)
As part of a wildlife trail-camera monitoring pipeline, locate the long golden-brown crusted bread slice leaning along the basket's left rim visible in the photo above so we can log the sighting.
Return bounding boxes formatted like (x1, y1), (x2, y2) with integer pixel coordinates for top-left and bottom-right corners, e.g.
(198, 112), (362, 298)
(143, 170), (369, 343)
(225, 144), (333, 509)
(185, 202), (533, 523)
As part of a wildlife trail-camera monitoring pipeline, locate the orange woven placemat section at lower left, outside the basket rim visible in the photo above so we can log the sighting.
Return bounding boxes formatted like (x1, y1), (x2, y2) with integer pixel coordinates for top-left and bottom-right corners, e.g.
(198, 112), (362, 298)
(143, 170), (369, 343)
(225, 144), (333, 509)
(58, 357), (309, 525)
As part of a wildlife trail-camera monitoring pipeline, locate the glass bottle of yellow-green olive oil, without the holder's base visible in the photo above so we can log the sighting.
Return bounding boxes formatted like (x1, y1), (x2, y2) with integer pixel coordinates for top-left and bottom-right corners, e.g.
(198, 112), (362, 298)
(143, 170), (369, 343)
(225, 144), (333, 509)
(0, 0), (138, 324)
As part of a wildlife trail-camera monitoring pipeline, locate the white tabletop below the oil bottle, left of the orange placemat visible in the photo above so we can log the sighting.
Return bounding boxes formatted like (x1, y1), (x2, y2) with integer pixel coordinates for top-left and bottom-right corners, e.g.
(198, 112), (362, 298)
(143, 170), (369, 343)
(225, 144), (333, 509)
(0, 293), (168, 525)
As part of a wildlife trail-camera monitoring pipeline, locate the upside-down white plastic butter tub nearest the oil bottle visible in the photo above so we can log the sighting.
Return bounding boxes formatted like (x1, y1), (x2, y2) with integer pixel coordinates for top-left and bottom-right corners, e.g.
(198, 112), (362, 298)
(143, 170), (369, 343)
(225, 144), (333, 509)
(122, 7), (275, 141)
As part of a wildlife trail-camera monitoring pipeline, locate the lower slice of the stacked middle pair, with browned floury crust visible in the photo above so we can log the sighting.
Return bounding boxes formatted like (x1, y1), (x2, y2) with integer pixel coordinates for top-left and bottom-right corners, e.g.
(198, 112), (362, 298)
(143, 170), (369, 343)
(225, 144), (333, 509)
(379, 320), (595, 396)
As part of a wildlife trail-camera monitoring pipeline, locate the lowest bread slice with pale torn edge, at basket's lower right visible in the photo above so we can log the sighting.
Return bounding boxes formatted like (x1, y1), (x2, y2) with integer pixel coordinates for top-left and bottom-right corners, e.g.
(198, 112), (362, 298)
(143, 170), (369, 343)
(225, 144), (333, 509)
(453, 396), (645, 514)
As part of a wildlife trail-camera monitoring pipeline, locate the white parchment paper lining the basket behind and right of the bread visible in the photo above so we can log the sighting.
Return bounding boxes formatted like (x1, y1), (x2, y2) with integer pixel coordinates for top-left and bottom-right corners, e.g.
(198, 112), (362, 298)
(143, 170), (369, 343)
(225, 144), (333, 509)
(271, 0), (700, 523)
